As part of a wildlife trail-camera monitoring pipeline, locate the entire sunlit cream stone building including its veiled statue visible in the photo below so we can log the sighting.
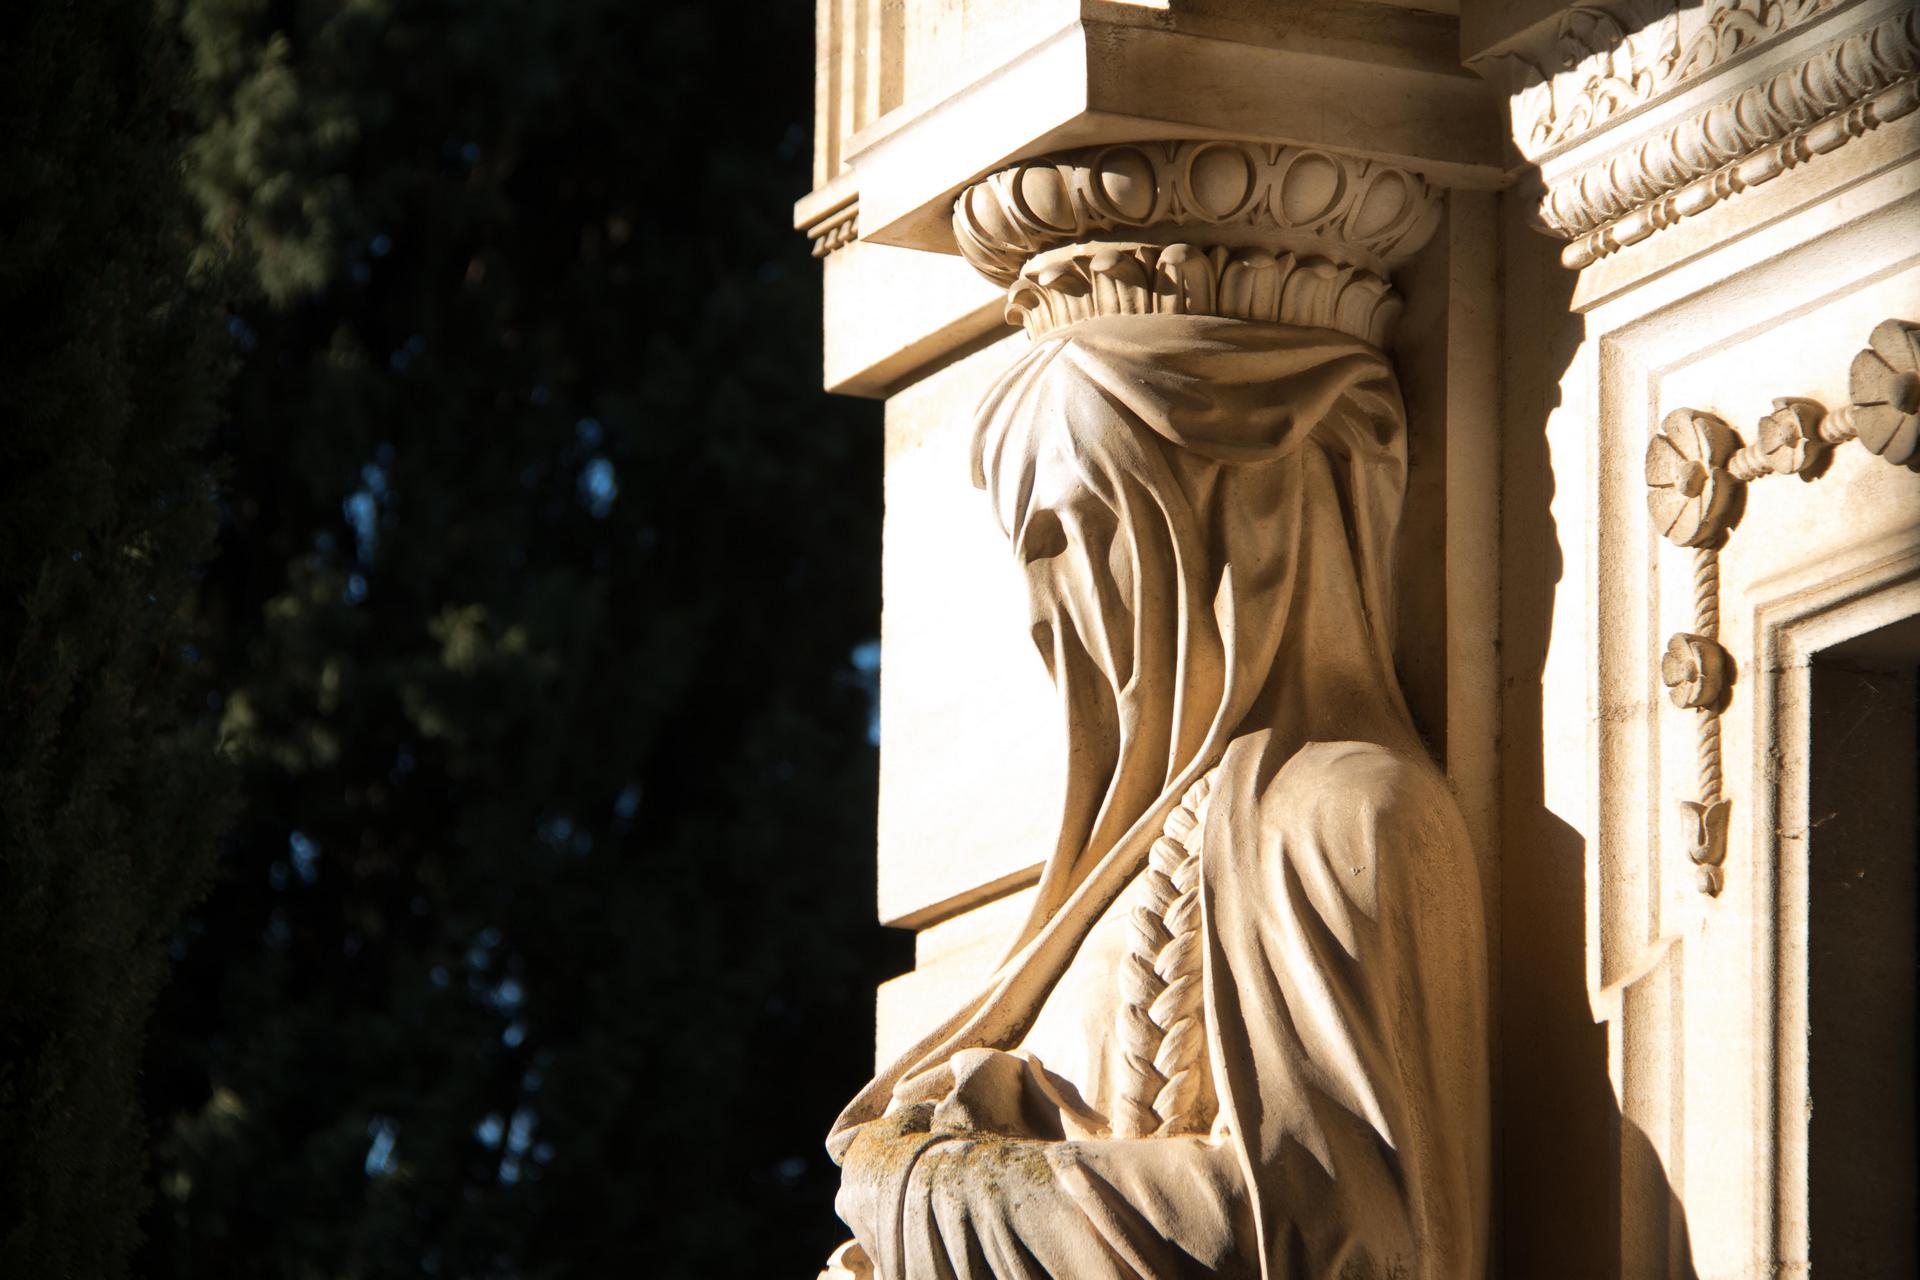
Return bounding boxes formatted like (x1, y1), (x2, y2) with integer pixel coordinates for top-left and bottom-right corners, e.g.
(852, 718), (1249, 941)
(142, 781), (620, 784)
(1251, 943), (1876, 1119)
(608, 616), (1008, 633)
(797, 0), (1920, 1280)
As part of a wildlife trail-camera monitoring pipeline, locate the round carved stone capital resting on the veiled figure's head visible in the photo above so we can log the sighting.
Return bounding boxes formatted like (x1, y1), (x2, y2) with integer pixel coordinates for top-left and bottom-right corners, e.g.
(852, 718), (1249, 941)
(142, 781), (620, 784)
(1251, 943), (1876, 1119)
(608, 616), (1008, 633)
(954, 142), (1440, 345)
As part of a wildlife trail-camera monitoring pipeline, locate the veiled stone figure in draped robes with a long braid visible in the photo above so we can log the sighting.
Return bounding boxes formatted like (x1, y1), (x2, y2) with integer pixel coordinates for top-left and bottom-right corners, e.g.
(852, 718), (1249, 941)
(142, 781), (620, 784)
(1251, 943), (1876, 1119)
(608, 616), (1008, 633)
(829, 315), (1488, 1280)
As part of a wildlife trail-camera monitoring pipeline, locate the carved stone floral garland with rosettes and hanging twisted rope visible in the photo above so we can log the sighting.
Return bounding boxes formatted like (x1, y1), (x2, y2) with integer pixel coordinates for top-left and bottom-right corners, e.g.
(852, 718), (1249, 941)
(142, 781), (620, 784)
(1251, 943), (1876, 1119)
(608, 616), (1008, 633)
(1645, 320), (1920, 894)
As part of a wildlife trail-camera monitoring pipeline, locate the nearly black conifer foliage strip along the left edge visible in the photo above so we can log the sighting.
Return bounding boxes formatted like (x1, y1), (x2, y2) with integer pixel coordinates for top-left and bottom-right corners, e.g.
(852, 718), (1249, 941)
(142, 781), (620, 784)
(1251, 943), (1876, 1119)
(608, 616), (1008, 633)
(0, 0), (227, 1278)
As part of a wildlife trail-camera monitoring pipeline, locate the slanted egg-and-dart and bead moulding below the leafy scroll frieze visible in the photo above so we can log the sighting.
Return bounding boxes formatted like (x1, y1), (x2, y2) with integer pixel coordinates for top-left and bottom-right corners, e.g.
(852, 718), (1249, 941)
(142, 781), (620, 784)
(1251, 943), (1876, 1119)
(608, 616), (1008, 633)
(1540, 10), (1920, 267)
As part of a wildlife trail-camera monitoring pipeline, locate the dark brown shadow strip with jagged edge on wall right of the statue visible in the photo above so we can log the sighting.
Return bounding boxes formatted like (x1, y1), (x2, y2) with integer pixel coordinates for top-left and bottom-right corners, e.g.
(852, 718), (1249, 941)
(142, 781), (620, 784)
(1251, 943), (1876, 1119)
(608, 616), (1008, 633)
(1492, 194), (1697, 1280)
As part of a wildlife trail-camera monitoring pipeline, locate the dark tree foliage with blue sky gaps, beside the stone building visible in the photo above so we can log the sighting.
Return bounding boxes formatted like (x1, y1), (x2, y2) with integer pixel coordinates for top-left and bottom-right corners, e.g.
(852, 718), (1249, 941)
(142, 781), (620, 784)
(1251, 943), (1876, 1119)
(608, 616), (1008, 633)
(140, 0), (891, 1280)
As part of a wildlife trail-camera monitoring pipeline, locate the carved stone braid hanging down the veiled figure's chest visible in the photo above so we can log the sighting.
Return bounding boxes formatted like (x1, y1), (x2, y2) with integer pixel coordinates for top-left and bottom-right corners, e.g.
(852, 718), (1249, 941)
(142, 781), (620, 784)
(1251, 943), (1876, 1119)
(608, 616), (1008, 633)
(1114, 777), (1215, 1138)
